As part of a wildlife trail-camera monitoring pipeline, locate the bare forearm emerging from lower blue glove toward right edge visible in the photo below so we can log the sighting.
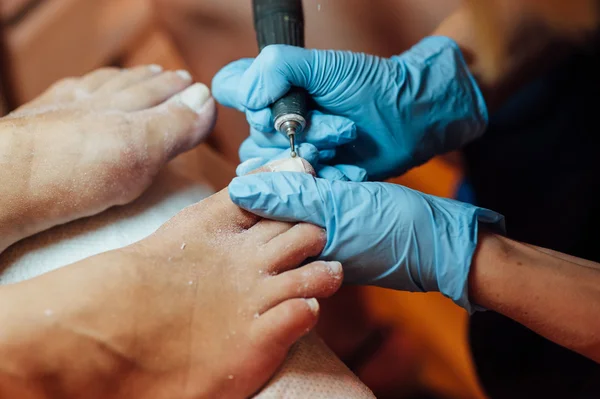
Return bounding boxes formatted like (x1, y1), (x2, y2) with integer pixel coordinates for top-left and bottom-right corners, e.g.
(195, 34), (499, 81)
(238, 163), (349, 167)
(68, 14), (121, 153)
(469, 232), (600, 362)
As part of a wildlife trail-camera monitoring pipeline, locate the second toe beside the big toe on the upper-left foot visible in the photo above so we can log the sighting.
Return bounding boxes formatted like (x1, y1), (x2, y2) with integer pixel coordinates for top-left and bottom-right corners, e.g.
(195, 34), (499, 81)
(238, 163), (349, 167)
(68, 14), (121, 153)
(106, 71), (192, 111)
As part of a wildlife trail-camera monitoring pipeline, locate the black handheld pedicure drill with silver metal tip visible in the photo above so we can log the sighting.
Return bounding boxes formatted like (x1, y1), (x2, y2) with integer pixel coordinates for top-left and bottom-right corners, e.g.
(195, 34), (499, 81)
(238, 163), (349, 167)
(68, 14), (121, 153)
(252, 0), (308, 158)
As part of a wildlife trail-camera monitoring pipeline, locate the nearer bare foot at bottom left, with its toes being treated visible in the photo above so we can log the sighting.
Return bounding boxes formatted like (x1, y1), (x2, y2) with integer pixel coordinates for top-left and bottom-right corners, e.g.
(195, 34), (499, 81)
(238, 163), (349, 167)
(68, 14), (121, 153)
(0, 191), (343, 398)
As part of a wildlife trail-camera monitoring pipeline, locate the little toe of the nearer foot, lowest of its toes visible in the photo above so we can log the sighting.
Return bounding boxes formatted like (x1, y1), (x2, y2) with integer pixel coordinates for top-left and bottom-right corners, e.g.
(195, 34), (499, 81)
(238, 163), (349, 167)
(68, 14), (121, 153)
(250, 298), (319, 358)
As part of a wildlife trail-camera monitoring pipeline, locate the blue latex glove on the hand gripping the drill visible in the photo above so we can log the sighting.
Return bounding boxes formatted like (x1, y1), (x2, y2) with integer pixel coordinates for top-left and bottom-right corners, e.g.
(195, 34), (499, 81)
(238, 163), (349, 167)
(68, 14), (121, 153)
(213, 37), (488, 180)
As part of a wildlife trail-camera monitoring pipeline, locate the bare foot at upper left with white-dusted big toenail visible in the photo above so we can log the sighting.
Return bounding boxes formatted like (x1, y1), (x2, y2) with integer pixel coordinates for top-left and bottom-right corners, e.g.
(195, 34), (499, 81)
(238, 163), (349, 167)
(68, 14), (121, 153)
(0, 66), (216, 250)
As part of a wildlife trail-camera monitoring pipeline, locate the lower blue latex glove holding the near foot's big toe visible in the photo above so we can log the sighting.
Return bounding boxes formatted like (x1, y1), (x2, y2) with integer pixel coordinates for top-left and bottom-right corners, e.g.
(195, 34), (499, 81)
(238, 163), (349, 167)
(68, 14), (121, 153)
(229, 172), (504, 311)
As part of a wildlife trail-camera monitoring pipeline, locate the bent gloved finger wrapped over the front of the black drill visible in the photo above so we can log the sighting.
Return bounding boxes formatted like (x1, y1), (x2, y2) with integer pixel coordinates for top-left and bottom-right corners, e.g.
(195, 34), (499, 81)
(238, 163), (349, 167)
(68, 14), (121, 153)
(239, 45), (314, 110)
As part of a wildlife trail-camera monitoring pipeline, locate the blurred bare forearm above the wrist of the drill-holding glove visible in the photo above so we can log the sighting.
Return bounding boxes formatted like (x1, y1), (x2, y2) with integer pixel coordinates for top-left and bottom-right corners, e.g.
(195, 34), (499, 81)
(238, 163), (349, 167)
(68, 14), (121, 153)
(433, 2), (568, 110)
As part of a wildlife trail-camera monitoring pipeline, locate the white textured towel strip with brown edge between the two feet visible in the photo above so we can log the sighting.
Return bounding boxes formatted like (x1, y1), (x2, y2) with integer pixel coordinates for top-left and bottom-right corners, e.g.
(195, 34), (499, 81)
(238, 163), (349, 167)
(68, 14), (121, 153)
(0, 164), (214, 284)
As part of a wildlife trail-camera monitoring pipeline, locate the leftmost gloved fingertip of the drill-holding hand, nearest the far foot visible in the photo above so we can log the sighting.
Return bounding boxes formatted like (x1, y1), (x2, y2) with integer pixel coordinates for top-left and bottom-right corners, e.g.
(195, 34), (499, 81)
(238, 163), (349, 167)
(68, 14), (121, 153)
(212, 58), (254, 112)
